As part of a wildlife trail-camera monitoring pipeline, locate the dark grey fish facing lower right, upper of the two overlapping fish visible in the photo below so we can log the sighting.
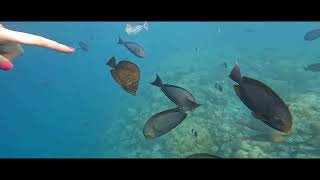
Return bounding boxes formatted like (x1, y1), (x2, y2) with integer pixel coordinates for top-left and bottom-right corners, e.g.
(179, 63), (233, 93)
(150, 74), (201, 111)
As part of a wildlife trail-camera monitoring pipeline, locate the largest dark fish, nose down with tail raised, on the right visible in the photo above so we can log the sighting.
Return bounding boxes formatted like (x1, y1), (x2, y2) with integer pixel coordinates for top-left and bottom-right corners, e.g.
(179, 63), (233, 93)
(229, 64), (292, 133)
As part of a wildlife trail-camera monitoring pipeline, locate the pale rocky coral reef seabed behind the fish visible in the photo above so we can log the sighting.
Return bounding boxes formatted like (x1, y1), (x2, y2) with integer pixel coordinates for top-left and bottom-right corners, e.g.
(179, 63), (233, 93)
(102, 50), (320, 158)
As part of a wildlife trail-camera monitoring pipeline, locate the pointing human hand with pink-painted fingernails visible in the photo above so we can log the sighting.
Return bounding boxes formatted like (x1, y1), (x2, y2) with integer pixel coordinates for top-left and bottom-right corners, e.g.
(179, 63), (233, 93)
(0, 24), (75, 70)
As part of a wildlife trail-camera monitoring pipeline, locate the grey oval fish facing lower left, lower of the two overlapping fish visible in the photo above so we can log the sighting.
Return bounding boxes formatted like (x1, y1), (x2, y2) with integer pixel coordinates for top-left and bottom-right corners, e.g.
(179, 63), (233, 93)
(143, 108), (187, 139)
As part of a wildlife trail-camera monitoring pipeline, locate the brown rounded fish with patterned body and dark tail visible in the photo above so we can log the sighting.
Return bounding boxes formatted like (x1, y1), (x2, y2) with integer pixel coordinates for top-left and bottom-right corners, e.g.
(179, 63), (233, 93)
(106, 56), (140, 96)
